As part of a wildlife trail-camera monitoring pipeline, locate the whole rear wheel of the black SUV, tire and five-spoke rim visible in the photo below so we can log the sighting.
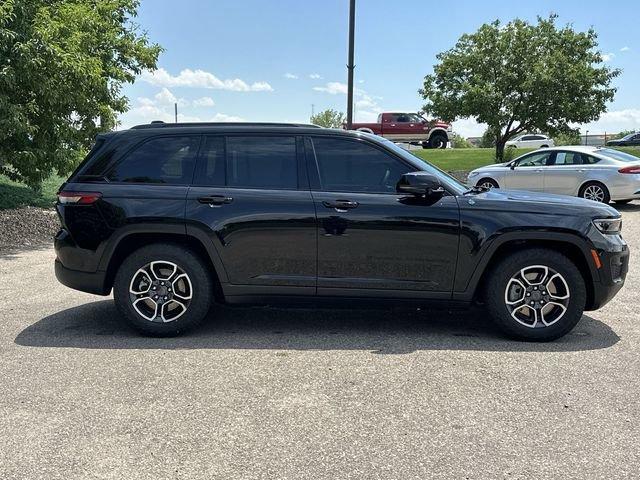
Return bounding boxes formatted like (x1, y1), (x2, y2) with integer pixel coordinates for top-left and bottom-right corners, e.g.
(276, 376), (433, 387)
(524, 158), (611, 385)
(113, 243), (213, 337)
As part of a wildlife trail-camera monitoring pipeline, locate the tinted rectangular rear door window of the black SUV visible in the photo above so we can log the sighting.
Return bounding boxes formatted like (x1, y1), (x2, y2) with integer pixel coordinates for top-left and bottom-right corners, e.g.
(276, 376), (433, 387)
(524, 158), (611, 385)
(227, 136), (298, 189)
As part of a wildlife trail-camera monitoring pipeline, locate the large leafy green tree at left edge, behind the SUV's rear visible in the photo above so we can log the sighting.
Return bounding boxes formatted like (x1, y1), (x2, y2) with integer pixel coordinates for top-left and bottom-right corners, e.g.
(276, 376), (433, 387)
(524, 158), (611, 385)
(0, 0), (161, 188)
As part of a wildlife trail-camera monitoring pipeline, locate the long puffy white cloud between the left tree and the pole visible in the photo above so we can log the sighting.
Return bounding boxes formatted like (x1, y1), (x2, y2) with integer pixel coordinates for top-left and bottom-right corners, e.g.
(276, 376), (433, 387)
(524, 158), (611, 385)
(140, 68), (273, 92)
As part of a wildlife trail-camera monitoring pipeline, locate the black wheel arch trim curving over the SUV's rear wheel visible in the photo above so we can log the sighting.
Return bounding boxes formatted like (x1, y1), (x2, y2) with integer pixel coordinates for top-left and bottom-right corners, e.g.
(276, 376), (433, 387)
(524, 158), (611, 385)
(104, 231), (226, 301)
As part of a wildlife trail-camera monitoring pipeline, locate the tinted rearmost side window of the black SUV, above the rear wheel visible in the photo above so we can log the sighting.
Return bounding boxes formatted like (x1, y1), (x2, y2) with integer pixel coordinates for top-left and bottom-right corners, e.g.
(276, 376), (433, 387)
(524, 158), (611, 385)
(107, 136), (200, 185)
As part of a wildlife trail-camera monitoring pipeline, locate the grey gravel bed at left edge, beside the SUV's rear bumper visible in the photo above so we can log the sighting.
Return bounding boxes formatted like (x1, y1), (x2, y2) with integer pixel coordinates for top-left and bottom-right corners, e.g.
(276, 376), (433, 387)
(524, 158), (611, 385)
(0, 207), (60, 253)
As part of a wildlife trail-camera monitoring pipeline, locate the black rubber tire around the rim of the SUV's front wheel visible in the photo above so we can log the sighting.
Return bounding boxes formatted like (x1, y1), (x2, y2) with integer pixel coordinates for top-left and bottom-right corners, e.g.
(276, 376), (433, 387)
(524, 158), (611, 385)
(485, 248), (587, 342)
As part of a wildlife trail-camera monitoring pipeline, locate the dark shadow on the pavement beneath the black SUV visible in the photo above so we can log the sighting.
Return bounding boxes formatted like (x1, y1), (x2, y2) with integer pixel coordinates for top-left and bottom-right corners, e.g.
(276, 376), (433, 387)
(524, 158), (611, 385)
(15, 300), (620, 354)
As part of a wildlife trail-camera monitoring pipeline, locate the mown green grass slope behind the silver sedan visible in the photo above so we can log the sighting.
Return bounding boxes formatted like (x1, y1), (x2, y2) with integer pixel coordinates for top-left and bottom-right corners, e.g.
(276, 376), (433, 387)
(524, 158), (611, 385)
(411, 147), (640, 172)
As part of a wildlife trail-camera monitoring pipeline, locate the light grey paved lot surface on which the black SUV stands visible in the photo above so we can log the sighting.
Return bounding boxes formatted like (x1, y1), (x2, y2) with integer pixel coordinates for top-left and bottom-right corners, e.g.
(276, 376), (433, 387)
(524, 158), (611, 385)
(0, 205), (640, 480)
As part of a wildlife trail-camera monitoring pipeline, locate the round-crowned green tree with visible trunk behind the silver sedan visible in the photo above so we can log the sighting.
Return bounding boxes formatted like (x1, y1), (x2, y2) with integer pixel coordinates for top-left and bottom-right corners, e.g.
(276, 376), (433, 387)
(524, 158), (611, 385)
(420, 15), (620, 161)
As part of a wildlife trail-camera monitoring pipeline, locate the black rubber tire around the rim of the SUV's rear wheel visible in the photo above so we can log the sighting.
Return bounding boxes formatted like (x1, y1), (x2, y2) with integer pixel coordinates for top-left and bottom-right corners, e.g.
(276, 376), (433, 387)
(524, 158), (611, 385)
(113, 243), (213, 337)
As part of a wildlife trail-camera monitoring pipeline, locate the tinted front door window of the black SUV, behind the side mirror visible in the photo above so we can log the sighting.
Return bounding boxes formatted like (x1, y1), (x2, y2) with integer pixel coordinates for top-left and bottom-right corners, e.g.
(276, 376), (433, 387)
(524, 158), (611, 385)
(313, 138), (414, 193)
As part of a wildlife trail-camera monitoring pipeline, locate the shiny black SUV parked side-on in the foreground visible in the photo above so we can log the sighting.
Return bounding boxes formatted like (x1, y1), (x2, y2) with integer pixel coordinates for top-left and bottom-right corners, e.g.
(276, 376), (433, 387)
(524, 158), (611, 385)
(55, 123), (629, 341)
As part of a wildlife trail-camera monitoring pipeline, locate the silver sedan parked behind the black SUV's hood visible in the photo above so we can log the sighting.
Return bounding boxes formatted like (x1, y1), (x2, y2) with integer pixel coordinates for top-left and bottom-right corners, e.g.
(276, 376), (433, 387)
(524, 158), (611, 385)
(468, 146), (640, 203)
